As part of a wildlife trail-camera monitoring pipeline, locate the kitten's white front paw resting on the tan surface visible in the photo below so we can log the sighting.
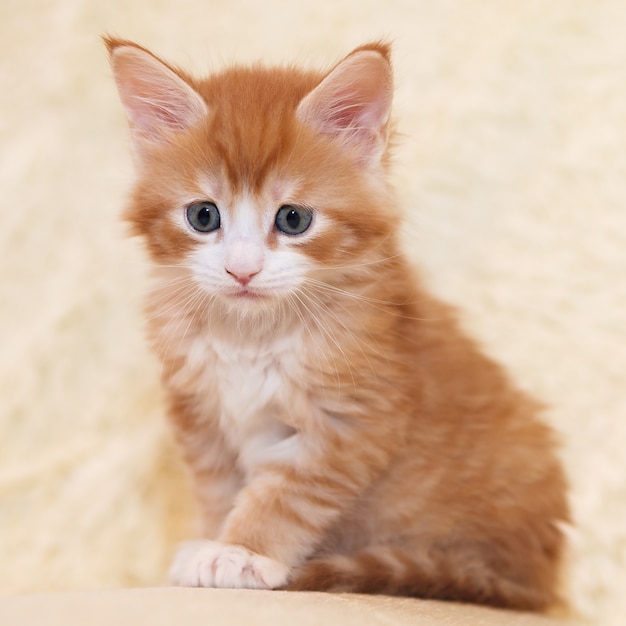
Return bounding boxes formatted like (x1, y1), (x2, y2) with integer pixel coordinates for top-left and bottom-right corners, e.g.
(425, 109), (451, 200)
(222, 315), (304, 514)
(170, 541), (288, 589)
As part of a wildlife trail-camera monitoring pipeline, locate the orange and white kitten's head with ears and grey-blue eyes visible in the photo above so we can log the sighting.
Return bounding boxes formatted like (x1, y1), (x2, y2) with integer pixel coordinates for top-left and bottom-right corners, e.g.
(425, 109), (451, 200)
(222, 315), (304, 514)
(106, 39), (398, 312)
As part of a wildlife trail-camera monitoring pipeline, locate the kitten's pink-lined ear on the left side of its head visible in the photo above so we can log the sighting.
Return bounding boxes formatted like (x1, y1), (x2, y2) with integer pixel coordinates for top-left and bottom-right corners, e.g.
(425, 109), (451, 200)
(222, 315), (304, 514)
(104, 38), (208, 154)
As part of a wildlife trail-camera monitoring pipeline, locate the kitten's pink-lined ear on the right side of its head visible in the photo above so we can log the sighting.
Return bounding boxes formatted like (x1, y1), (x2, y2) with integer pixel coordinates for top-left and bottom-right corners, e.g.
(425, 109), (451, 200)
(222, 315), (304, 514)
(296, 44), (393, 161)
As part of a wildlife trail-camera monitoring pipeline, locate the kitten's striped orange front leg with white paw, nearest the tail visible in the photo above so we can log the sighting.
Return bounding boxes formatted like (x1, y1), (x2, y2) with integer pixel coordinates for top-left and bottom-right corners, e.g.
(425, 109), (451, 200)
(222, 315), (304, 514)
(171, 416), (389, 588)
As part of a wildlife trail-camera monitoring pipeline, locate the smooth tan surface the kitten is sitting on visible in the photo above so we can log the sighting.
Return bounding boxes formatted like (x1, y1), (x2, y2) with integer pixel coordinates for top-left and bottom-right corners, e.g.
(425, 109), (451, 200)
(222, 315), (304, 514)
(0, 588), (566, 626)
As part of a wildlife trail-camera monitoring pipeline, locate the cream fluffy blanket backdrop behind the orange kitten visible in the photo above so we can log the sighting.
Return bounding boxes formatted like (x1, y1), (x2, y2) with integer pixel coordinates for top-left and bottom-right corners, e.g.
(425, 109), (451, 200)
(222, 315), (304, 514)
(0, 0), (626, 626)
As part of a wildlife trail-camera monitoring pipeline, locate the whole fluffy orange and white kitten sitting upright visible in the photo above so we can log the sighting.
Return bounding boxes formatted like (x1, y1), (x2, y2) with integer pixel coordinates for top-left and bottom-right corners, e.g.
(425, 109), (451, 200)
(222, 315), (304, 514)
(106, 39), (569, 610)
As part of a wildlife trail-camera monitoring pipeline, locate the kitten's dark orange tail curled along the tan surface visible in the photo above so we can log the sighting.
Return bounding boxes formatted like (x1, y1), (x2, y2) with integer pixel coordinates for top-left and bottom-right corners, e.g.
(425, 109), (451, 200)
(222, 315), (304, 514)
(287, 545), (557, 611)
